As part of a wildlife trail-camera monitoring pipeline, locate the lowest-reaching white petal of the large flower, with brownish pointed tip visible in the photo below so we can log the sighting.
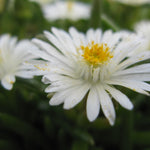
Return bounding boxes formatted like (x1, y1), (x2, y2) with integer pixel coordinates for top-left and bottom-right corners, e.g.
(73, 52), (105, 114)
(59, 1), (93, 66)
(97, 86), (116, 125)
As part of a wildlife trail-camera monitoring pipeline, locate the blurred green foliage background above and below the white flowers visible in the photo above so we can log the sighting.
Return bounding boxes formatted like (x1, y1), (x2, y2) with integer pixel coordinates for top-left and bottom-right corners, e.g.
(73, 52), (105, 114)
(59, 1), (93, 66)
(0, 0), (150, 150)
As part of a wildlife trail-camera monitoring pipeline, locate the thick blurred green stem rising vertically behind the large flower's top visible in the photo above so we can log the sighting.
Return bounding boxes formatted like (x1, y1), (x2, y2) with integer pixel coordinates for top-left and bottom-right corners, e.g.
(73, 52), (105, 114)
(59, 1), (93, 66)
(90, 0), (102, 28)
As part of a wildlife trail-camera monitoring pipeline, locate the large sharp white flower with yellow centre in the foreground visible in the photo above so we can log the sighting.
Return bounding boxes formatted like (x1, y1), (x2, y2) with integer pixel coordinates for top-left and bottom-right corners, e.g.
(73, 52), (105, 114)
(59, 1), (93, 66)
(32, 27), (150, 125)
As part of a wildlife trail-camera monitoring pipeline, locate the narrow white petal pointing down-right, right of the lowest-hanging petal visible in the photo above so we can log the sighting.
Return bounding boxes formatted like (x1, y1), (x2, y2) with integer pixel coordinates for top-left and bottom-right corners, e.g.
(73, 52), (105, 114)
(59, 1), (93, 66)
(105, 85), (133, 110)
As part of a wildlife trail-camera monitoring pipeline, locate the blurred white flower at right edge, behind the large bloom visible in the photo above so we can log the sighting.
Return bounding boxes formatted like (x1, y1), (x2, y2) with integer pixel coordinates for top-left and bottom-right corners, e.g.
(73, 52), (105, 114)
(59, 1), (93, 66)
(134, 20), (150, 50)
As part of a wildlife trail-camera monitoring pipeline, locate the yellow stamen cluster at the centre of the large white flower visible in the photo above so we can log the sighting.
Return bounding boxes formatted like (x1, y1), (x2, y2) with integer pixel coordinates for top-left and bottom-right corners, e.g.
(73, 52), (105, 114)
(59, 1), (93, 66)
(80, 41), (113, 66)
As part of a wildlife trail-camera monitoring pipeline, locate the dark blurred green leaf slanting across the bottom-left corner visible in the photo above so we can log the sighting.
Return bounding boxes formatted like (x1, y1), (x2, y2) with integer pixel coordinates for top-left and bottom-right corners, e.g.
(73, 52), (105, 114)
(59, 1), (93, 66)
(0, 113), (46, 147)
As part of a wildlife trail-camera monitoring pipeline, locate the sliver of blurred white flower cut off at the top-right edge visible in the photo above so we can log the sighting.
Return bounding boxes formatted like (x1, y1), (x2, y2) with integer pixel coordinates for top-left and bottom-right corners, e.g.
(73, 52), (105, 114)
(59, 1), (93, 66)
(110, 0), (150, 6)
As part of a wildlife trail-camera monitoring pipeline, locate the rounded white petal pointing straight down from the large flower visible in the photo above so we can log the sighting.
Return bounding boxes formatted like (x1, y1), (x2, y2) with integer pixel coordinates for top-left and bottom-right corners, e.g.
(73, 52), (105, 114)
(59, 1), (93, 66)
(86, 87), (100, 121)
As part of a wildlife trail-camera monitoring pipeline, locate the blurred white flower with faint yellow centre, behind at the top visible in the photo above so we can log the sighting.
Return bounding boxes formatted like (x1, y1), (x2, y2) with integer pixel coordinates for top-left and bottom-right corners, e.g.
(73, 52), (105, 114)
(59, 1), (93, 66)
(42, 1), (90, 21)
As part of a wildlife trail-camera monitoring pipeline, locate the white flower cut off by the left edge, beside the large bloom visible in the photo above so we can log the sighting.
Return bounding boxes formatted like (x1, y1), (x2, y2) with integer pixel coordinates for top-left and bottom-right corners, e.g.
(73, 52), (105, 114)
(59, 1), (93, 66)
(0, 34), (37, 90)
